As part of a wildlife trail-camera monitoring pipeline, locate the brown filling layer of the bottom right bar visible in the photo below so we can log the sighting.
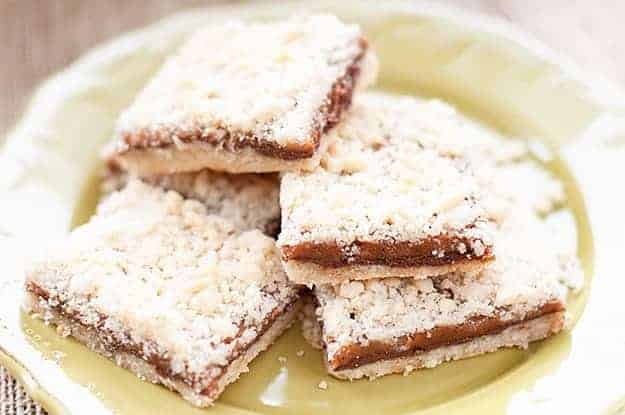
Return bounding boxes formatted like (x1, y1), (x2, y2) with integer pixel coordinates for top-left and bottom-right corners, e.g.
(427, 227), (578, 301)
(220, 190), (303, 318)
(329, 302), (564, 370)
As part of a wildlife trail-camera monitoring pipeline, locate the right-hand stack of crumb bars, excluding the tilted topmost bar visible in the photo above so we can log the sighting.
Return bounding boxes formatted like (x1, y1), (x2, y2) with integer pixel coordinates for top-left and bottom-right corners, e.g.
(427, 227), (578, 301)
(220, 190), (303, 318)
(286, 93), (581, 379)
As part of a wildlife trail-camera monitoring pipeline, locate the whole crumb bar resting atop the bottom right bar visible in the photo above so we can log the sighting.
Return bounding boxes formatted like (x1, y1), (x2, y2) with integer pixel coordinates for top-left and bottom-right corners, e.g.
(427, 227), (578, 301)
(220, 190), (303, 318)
(278, 93), (493, 284)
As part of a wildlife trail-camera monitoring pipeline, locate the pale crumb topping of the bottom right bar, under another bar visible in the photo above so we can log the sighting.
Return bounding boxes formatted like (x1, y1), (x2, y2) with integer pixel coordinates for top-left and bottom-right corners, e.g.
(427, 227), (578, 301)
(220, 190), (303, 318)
(315, 210), (581, 359)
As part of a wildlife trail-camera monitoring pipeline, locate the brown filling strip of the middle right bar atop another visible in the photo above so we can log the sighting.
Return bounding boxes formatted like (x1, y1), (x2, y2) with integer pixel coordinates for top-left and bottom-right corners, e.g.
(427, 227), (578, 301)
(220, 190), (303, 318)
(281, 236), (493, 268)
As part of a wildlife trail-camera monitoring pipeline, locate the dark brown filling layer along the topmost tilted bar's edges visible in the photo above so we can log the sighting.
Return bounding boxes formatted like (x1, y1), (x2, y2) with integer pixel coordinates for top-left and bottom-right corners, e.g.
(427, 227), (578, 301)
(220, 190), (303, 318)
(118, 38), (368, 160)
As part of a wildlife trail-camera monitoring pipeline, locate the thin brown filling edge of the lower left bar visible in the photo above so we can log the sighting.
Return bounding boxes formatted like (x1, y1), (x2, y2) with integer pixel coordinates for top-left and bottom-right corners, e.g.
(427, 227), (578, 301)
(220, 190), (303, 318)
(26, 282), (299, 397)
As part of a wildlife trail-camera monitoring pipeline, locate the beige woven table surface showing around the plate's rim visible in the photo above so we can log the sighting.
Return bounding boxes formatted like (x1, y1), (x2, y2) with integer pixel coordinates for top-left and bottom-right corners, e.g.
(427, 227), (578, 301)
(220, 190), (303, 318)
(0, 0), (625, 415)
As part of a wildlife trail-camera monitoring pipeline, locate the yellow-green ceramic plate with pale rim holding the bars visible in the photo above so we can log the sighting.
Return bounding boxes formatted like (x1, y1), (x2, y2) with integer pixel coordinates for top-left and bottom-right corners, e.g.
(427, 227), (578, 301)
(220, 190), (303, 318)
(0, 2), (625, 415)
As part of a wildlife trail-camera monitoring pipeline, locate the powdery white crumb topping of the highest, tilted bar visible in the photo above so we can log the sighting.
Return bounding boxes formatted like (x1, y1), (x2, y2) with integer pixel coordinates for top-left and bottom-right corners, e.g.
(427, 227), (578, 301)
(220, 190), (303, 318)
(118, 15), (371, 149)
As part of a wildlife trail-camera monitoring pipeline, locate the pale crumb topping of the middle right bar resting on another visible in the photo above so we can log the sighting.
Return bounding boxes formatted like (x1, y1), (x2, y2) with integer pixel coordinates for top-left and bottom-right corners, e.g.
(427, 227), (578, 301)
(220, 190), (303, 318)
(279, 93), (492, 256)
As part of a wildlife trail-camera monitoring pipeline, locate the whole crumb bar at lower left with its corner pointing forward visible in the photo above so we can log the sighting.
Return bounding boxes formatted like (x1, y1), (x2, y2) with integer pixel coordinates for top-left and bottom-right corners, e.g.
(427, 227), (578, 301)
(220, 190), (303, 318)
(26, 180), (299, 406)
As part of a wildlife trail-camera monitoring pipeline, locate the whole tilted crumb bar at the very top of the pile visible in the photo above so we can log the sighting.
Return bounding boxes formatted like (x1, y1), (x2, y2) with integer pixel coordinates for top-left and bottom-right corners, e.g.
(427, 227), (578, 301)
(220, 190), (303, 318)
(109, 15), (377, 175)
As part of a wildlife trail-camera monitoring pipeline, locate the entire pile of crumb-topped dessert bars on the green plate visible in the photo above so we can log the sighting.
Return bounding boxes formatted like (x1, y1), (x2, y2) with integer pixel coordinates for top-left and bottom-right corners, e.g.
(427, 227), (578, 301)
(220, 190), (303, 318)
(25, 11), (581, 406)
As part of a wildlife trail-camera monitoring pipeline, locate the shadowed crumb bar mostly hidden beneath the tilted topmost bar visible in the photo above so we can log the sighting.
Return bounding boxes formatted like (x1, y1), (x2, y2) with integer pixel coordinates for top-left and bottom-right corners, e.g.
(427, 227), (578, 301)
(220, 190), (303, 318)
(102, 166), (280, 238)
